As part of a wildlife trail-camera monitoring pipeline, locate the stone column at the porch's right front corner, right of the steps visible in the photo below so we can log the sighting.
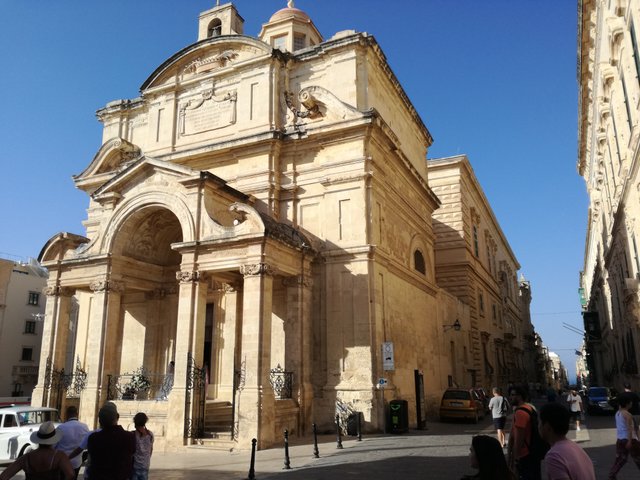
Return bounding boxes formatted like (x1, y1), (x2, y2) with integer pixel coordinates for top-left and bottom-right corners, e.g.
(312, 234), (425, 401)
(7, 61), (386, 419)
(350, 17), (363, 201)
(236, 263), (275, 449)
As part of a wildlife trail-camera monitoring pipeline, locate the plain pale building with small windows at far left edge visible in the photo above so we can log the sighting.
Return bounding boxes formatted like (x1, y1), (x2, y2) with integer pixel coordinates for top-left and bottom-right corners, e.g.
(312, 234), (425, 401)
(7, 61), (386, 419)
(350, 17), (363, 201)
(0, 258), (47, 397)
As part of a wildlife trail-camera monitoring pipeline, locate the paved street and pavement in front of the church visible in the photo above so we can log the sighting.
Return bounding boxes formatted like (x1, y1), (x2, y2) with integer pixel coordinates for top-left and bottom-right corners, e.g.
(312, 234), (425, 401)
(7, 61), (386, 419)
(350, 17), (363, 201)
(2, 408), (640, 480)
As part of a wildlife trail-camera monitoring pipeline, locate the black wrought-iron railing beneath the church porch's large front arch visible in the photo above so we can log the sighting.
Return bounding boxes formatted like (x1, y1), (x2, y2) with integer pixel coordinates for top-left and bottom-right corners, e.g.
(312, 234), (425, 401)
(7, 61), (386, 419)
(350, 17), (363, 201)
(107, 367), (173, 400)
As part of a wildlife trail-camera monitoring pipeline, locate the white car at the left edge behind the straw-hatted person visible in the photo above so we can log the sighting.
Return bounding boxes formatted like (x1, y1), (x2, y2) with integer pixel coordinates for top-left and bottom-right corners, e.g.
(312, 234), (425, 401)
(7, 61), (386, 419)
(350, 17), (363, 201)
(0, 405), (58, 463)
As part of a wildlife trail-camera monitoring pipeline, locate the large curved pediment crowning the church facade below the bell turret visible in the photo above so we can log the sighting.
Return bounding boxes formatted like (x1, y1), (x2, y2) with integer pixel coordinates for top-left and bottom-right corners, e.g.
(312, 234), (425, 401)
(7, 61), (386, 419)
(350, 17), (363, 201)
(140, 35), (272, 92)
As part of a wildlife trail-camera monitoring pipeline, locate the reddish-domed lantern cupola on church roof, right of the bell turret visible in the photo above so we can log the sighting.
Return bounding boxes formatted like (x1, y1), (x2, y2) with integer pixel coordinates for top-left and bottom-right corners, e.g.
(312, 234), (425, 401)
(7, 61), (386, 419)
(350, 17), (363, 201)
(258, 0), (323, 52)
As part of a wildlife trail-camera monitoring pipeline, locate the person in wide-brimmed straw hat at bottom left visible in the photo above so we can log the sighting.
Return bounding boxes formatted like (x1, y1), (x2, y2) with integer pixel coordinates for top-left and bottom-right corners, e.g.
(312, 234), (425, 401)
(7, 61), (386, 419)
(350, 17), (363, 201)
(0, 422), (75, 480)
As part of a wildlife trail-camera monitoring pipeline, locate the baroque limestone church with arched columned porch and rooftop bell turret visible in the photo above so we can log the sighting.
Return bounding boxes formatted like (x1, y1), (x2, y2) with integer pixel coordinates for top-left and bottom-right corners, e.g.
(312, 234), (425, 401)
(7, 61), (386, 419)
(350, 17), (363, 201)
(33, 1), (532, 449)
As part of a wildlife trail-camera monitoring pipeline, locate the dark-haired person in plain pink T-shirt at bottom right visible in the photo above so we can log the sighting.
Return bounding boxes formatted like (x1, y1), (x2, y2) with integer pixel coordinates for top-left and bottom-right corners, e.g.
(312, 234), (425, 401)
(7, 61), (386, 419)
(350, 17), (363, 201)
(539, 403), (596, 480)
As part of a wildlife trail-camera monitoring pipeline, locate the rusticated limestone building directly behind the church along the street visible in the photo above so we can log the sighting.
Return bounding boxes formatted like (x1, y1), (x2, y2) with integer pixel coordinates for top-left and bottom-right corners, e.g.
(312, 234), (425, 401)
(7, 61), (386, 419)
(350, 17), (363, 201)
(428, 159), (540, 387)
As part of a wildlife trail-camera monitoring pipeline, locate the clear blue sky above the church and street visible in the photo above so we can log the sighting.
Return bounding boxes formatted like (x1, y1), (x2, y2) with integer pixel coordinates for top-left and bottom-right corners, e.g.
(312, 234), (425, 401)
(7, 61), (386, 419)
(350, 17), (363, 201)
(0, 0), (587, 380)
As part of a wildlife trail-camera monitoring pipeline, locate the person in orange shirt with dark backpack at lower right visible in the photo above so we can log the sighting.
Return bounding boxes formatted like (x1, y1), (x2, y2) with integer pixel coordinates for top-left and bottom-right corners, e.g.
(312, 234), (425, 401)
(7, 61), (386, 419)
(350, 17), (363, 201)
(507, 386), (549, 480)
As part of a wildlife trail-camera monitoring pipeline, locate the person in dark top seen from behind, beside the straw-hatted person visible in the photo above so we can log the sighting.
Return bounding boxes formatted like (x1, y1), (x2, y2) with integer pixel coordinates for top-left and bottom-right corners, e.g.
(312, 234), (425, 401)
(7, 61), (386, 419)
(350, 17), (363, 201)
(87, 406), (136, 480)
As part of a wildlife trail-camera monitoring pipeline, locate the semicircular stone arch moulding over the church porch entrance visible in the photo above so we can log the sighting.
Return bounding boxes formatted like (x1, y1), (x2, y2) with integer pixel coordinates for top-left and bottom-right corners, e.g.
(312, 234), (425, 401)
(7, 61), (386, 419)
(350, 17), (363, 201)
(100, 191), (196, 253)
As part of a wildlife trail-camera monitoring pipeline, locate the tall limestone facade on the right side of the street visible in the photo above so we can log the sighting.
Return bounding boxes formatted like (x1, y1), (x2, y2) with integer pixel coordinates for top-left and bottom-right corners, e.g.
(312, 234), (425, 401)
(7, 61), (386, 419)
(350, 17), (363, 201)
(578, 0), (640, 390)
